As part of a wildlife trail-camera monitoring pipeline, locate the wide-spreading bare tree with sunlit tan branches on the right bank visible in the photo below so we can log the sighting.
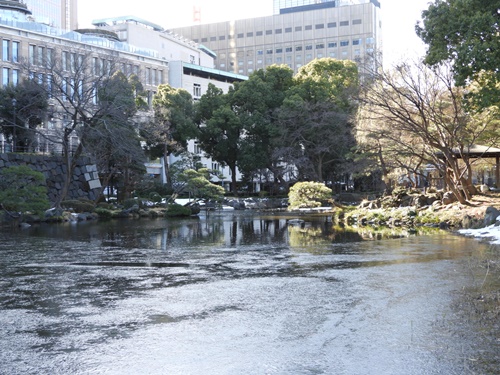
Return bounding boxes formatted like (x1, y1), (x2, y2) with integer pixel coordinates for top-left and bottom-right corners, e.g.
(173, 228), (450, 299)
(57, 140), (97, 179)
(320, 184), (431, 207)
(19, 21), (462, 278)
(361, 62), (497, 203)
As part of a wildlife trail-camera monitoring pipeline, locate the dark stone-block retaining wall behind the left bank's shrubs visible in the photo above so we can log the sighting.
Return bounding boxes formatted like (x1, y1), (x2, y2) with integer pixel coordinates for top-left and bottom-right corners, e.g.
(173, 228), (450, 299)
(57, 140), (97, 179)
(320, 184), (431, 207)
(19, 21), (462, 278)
(0, 154), (101, 203)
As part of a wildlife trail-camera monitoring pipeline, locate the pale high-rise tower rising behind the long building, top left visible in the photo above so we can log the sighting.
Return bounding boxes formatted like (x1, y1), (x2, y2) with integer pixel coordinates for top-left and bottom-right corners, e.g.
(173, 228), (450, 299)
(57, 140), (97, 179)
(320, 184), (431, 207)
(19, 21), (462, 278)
(24, 0), (78, 30)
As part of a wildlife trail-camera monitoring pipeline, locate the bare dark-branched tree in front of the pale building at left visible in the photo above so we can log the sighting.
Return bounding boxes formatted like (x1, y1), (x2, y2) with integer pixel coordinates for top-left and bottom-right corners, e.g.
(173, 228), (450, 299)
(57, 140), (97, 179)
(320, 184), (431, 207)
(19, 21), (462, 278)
(23, 49), (143, 206)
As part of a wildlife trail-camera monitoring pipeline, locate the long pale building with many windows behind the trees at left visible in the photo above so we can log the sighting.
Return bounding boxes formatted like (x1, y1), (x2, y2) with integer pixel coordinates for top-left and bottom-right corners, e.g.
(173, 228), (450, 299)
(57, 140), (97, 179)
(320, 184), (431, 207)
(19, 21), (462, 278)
(0, 0), (247, 191)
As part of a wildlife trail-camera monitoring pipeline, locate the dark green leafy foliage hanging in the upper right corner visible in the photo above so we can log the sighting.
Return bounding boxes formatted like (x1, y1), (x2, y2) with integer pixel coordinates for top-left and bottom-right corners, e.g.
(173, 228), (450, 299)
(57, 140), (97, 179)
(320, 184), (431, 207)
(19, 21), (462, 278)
(416, 0), (500, 107)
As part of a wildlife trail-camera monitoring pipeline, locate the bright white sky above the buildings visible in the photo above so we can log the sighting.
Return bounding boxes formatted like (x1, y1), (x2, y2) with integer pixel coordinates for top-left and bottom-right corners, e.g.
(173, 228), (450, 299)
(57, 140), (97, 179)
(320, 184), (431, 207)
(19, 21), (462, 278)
(78, 0), (430, 67)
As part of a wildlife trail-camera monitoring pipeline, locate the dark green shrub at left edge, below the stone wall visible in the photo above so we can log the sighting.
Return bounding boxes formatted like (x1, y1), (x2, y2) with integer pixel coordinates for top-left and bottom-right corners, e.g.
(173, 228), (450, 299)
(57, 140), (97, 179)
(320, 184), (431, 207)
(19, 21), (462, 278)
(0, 166), (50, 214)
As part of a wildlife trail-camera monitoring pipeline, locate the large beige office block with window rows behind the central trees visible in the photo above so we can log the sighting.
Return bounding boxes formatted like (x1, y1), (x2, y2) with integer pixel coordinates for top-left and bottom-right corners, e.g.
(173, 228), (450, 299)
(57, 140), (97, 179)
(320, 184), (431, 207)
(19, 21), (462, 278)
(171, 0), (382, 75)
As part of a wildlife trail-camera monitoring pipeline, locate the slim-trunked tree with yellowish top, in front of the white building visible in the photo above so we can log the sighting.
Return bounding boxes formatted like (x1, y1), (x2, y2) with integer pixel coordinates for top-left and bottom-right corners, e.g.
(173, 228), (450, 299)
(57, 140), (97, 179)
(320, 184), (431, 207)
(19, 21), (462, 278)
(142, 84), (196, 186)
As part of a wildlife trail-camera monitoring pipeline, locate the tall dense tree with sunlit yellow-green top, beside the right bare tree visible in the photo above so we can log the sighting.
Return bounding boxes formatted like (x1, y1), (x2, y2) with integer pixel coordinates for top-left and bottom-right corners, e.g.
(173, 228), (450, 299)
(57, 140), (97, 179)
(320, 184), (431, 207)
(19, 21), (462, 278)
(280, 58), (359, 181)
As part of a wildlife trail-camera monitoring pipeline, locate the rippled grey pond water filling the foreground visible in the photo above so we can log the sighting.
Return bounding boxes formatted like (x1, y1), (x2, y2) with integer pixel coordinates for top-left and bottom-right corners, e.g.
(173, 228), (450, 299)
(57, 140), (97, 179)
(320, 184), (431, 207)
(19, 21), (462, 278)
(0, 211), (500, 375)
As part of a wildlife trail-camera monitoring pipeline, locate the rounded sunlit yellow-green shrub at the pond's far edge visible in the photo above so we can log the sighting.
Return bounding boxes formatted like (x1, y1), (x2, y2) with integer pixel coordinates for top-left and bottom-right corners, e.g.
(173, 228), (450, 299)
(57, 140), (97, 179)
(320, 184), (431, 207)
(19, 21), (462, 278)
(288, 182), (332, 210)
